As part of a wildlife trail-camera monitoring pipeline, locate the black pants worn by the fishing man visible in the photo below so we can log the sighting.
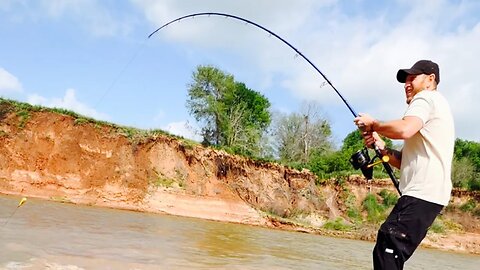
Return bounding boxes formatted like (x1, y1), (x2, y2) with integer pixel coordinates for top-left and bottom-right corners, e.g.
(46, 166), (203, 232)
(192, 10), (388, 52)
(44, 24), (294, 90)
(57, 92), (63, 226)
(373, 196), (443, 270)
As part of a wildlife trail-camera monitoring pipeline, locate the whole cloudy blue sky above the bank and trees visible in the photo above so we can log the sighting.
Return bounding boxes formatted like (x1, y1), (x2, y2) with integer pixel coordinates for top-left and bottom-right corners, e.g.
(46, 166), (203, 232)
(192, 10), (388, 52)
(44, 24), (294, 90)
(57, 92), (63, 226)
(0, 0), (480, 146)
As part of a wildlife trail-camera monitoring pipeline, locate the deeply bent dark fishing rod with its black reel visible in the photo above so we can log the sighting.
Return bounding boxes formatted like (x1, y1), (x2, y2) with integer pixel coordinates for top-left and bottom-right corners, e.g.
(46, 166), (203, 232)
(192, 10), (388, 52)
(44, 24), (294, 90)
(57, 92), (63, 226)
(148, 12), (401, 195)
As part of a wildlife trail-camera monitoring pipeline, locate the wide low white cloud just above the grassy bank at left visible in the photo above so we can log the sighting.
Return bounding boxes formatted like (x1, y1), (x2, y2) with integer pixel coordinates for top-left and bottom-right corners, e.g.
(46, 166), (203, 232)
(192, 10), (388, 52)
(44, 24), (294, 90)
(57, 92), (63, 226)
(27, 88), (110, 121)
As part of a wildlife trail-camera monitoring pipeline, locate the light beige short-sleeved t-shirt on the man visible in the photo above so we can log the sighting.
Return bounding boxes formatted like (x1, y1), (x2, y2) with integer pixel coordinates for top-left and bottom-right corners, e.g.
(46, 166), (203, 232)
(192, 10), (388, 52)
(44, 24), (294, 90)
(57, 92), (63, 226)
(400, 90), (455, 205)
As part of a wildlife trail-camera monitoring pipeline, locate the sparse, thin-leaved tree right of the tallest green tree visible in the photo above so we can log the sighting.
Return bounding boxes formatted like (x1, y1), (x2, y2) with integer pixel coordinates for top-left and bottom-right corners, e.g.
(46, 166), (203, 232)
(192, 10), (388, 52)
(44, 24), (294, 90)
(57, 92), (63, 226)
(273, 103), (332, 164)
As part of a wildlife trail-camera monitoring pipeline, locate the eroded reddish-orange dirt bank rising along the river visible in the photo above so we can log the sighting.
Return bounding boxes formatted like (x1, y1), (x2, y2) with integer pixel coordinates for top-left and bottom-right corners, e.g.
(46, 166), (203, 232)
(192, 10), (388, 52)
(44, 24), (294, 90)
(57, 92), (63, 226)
(0, 102), (480, 254)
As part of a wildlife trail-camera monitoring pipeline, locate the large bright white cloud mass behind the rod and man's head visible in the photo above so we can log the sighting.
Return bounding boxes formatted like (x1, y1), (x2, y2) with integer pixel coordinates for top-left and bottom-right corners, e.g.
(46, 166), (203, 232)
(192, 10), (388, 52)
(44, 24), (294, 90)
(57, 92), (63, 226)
(134, 0), (480, 140)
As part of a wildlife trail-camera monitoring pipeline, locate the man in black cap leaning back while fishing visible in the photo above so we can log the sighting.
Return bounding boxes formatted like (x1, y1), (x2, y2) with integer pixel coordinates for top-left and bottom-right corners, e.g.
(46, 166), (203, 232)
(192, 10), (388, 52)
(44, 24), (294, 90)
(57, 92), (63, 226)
(354, 60), (455, 270)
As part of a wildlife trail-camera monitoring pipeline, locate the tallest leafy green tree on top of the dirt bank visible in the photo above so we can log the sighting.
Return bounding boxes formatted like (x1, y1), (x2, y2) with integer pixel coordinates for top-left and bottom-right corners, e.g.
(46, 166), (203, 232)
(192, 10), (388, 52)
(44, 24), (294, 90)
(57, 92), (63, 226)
(187, 66), (271, 155)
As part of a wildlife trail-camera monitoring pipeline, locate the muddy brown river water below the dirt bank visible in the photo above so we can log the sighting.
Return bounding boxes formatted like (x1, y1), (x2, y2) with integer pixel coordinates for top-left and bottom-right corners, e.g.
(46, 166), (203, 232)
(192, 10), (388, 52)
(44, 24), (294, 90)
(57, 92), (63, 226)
(0, 195), (480, 270)
